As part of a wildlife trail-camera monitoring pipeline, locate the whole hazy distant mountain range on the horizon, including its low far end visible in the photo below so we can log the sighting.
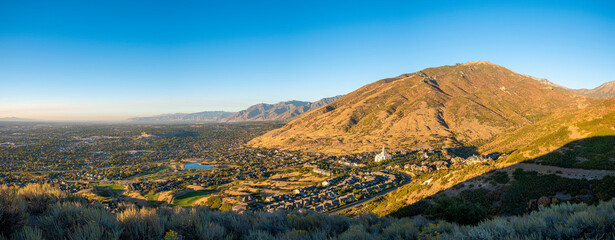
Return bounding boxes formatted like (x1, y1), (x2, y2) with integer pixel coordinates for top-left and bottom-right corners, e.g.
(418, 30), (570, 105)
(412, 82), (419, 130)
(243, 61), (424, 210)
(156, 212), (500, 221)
(129, 96), (341, 123)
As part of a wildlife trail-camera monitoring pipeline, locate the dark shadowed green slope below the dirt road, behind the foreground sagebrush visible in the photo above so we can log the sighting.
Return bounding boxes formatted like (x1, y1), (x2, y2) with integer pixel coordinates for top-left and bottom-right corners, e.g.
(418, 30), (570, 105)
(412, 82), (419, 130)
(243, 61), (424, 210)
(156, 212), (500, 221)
(391, 169), (615, 224)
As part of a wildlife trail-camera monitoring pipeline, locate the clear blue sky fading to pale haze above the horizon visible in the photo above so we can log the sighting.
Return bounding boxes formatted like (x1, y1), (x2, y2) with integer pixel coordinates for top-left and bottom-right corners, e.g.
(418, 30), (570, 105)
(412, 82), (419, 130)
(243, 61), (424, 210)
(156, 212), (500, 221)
(0, 0), (615, 120)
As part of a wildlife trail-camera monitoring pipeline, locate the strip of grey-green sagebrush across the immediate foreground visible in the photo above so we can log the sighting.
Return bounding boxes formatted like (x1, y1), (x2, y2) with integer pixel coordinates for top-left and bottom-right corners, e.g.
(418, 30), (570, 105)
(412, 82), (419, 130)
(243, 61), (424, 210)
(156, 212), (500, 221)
(0, 185), (615, 240)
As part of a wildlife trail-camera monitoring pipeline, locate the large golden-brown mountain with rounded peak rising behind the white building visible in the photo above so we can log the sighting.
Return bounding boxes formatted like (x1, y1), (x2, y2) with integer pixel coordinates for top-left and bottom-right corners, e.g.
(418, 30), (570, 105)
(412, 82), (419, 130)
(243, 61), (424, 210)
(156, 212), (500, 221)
(249, 61), (597, 154)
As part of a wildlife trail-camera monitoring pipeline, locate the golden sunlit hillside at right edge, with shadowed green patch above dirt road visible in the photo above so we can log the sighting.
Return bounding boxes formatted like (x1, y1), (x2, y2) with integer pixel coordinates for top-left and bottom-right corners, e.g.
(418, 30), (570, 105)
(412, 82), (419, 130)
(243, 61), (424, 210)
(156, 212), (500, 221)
(479, 99), (615, 169)
